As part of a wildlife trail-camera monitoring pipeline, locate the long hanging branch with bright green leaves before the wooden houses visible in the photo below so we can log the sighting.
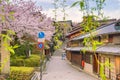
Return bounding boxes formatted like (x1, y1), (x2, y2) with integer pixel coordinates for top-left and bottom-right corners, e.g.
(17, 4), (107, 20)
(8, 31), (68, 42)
(71, 0), (111, 80)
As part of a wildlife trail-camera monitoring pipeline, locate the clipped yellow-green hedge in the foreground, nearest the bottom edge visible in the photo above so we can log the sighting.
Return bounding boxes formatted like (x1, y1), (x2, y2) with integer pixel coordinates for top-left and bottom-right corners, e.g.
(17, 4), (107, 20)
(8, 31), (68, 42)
(8, 67), (34, 80)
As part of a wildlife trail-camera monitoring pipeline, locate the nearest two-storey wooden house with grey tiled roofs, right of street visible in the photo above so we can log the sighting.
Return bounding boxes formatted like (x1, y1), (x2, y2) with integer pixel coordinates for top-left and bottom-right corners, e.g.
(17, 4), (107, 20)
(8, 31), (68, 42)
(66, 18), (120, 80)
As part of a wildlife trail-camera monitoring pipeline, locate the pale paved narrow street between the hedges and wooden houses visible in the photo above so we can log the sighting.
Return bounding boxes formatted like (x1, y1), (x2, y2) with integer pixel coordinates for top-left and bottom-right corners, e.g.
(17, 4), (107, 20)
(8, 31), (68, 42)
(43, 49), (98, 80)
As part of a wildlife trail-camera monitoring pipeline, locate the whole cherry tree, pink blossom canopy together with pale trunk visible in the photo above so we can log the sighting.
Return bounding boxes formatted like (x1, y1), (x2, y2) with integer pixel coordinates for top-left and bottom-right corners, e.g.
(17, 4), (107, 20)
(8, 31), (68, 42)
(0, 0), (54, 74)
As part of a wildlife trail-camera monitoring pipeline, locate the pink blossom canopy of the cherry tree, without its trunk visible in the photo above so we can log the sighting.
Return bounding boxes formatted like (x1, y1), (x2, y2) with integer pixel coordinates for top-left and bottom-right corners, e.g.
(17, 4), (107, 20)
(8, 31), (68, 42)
(0, 0), (54, 40)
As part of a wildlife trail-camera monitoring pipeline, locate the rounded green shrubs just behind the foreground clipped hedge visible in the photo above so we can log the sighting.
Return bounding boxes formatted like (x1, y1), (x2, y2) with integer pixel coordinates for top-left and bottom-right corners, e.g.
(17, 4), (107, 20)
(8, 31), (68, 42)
(11, 55), (40, 67)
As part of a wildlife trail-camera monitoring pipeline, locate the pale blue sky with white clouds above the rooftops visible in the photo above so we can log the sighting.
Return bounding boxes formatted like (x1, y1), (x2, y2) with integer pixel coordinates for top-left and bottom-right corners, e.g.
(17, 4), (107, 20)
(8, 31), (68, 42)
(30, 0), (120, 22)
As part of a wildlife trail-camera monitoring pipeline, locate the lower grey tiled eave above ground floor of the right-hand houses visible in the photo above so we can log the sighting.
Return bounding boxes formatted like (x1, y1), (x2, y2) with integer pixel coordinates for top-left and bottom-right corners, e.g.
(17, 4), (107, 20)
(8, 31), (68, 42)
(66, 45), (120, 55)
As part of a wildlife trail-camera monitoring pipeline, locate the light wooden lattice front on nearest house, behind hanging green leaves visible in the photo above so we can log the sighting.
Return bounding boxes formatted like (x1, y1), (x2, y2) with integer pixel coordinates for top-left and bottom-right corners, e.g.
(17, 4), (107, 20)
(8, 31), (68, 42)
(99, 54), (116, 80)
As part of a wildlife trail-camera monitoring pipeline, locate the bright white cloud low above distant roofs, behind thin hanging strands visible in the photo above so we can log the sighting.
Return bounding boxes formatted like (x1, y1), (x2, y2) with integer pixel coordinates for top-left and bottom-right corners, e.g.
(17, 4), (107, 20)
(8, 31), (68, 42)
(43, 7), (83, 22)
